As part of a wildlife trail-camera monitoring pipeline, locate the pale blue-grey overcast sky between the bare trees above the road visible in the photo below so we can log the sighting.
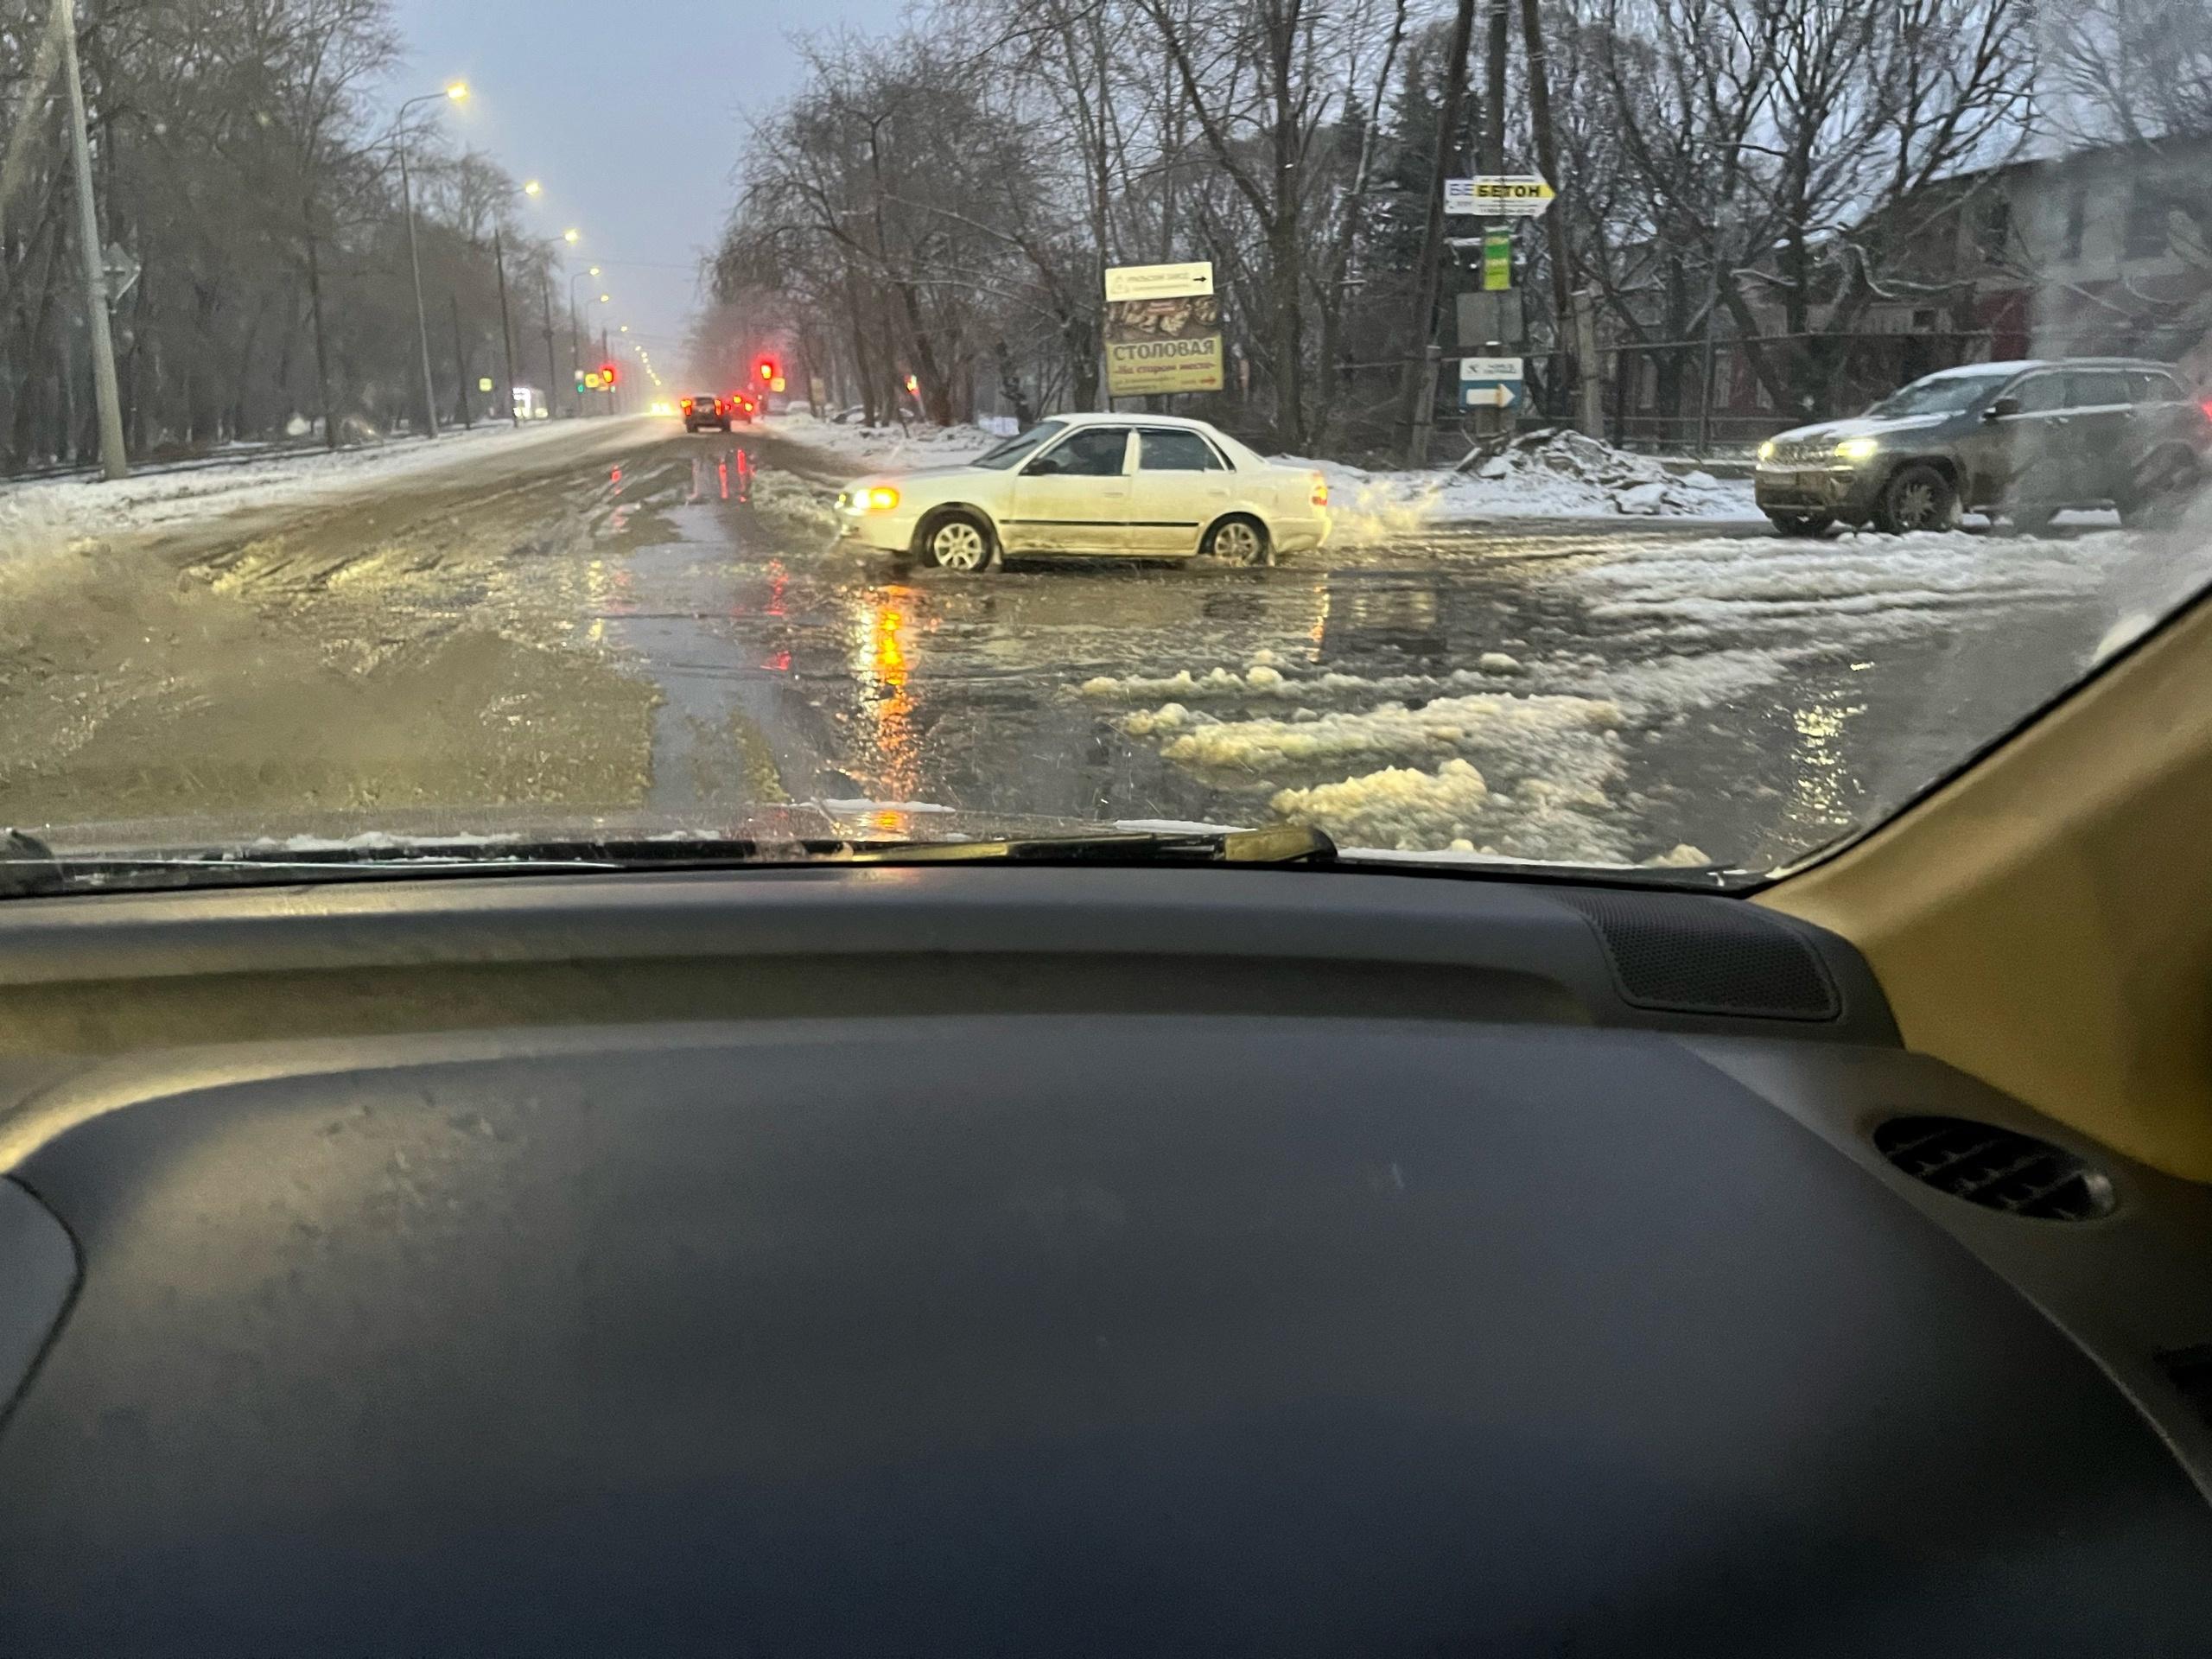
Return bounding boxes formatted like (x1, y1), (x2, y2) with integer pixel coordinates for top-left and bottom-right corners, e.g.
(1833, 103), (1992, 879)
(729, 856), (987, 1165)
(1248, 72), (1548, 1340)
(390, 0), (905, 367)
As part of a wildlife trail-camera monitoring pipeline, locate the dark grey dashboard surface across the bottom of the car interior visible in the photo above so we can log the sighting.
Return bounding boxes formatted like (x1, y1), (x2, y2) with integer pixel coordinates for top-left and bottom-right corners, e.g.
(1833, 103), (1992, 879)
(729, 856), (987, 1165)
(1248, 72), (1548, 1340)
(0, 872), (2212, 1655)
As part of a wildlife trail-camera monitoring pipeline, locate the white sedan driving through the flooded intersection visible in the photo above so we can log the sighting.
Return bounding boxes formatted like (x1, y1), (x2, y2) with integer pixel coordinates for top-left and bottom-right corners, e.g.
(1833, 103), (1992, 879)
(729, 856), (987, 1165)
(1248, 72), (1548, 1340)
(836, 414), (1330, 570)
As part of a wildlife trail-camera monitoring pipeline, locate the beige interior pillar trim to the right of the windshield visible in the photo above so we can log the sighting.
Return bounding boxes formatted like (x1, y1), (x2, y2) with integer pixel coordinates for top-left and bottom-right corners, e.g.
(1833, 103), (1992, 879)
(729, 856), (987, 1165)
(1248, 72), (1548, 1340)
(1757, 601), (2212, 1181)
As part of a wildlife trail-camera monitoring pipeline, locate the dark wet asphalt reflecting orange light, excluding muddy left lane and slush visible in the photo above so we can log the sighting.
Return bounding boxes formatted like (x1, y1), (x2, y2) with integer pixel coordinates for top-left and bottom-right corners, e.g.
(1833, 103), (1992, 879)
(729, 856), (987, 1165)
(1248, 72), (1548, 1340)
(586, 431), (2141, 869)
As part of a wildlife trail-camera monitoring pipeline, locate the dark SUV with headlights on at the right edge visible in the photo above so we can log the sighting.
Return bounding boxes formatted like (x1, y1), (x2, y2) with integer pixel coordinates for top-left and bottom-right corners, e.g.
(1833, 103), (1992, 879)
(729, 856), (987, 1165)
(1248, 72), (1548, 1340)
(1757, 359), (2212, 536)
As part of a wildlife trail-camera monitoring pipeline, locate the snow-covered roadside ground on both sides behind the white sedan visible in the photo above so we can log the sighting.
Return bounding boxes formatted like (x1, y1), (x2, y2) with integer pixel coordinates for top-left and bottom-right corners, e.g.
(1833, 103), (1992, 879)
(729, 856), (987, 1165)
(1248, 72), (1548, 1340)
(774, 414), (1758, 528)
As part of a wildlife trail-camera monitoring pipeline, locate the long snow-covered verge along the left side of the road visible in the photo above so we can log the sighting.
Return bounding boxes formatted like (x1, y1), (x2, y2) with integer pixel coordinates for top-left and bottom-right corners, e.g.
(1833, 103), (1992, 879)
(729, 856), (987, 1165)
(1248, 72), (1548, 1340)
(0, 420), (623, 564)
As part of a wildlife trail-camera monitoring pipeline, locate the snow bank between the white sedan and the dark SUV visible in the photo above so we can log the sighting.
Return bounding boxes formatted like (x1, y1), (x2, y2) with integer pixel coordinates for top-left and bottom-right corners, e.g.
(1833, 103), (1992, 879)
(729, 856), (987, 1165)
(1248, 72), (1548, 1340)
(1292, 431), (1758, 542)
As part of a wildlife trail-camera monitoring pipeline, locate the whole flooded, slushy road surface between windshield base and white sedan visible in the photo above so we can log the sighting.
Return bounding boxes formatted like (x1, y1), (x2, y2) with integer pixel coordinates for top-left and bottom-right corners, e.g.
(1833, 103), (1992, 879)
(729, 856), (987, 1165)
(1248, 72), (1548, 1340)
(0, 423), (2164, 868)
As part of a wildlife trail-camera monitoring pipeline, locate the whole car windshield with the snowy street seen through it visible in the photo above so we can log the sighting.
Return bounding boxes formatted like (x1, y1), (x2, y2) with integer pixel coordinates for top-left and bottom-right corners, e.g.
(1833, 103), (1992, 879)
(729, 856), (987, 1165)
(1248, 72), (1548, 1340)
(0, 0), (2212, 887)
